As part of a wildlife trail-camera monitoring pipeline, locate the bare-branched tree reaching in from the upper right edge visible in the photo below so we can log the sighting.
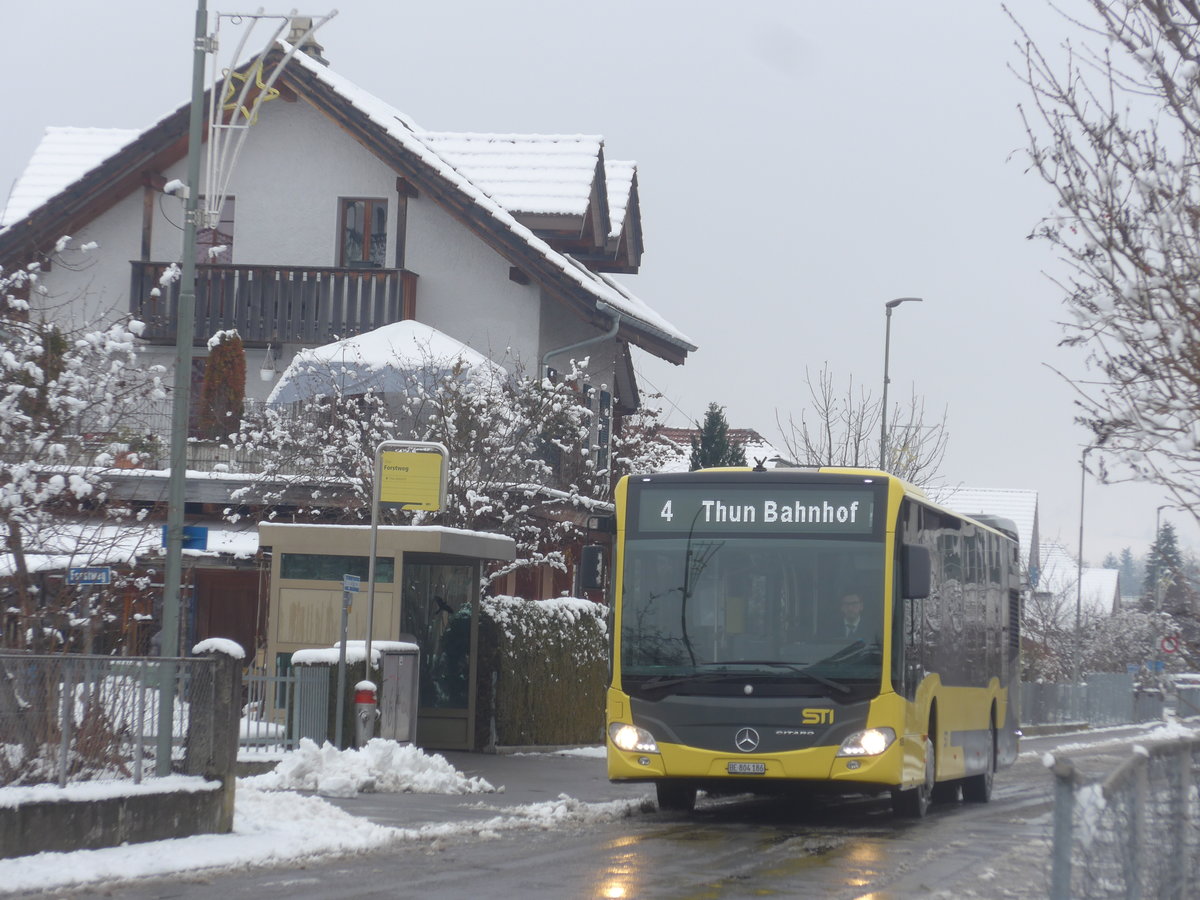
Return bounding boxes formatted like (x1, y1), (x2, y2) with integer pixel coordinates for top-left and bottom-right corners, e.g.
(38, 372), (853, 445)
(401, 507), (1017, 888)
(1009, 0), (1200, 518)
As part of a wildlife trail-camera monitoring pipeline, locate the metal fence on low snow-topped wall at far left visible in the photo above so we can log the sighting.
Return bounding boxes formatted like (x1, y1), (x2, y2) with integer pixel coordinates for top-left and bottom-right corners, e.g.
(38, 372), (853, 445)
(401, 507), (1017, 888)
(0, 653), (212, 786)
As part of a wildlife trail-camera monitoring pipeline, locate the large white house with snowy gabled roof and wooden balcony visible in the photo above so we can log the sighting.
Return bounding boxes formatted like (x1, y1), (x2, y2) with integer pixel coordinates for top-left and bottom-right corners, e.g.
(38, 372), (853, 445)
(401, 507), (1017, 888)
(0, 30), (696, 429)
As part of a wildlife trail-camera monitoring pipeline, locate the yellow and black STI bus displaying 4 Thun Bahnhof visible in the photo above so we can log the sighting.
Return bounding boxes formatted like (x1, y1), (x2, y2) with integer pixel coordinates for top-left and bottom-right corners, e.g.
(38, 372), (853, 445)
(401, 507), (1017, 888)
(606, 468), (1021, 817)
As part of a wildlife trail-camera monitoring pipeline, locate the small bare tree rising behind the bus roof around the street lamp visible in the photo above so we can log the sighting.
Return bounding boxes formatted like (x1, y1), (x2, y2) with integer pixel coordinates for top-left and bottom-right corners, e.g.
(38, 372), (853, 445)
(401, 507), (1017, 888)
(775, 364), (949, 486)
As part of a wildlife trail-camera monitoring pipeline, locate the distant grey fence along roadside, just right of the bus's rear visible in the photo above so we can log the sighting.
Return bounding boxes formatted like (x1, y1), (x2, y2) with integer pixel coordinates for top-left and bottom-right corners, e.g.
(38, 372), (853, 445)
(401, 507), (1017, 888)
(1021, 672), (1164, 728)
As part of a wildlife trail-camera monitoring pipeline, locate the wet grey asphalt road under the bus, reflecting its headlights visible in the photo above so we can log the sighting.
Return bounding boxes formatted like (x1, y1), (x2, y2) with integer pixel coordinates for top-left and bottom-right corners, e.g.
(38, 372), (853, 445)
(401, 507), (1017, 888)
(37, 730), (1161, 900)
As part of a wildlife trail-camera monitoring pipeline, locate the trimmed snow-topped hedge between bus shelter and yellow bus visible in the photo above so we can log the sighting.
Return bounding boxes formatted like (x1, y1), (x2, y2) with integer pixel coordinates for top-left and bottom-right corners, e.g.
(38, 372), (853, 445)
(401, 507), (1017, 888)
(476, 596), (608, 746)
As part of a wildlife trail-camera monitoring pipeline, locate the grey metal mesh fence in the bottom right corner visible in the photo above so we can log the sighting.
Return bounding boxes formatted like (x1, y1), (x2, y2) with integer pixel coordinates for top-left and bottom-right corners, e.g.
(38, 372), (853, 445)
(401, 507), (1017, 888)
(1050, 739), (1200, 900)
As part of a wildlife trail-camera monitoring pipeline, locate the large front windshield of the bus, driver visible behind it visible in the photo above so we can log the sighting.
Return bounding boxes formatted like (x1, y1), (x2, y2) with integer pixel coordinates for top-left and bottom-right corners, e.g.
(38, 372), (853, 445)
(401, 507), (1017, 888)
(620, 534), (884, 684)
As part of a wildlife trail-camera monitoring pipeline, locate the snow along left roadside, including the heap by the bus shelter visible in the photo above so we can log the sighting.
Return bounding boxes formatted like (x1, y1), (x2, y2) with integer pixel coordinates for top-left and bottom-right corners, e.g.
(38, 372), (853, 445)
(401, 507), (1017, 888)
(0, 739), (641, 894)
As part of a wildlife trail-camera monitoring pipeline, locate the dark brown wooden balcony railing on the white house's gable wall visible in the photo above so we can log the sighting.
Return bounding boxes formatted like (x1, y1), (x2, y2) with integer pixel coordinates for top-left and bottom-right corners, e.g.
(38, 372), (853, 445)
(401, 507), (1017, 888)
(130, 260), (416, 346)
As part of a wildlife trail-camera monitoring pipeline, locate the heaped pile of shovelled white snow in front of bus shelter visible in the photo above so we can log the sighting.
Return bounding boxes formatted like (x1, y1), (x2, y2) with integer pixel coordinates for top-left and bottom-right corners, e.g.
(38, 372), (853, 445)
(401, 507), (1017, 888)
(238, 738), (496, 797)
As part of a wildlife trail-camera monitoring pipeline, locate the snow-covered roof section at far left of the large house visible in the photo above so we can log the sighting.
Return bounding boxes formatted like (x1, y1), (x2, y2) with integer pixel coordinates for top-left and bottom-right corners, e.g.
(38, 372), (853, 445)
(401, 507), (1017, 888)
(0, 126), (142, 228)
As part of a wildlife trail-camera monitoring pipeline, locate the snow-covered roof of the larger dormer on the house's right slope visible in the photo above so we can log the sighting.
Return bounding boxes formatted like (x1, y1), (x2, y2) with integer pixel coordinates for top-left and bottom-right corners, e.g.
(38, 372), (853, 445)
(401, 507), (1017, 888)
(416, 130), (604, 216)
